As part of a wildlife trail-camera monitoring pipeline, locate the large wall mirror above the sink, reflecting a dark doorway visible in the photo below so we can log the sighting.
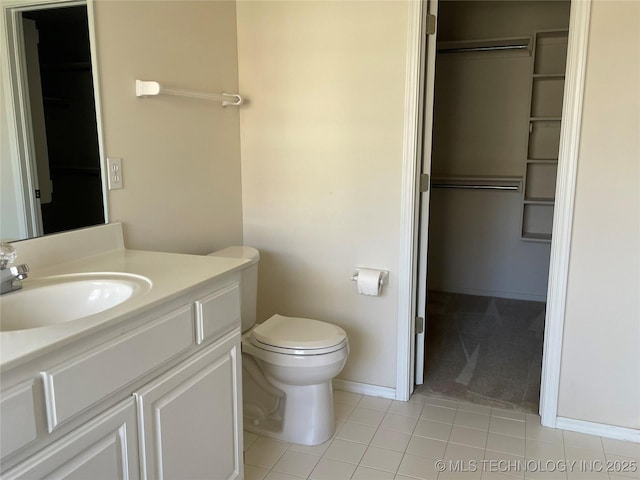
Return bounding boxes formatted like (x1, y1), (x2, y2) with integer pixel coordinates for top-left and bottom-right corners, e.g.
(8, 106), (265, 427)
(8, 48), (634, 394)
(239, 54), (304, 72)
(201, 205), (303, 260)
(0, 1), (106, 241)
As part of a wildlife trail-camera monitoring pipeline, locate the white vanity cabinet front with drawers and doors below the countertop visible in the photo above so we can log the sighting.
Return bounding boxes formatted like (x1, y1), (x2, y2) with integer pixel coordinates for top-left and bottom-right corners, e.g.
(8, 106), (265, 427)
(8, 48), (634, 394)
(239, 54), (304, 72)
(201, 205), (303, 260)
(0, 276), (243, 480)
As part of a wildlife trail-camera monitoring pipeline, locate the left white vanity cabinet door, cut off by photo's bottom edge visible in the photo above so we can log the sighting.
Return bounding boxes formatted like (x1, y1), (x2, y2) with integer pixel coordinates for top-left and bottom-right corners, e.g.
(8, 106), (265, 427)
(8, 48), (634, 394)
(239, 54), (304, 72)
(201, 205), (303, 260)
(2, 397), (139, 480)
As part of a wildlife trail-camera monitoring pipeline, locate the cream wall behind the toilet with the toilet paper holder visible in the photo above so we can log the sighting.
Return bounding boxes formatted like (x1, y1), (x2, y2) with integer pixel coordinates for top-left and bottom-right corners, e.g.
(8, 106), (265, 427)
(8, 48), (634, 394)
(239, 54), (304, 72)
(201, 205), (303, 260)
(237, 1), (408, 388)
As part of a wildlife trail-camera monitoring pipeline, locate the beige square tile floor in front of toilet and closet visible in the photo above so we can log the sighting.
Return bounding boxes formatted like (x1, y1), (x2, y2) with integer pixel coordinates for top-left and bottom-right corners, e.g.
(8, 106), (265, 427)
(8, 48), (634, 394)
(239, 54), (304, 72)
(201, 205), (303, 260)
(244, 390), (640, 480)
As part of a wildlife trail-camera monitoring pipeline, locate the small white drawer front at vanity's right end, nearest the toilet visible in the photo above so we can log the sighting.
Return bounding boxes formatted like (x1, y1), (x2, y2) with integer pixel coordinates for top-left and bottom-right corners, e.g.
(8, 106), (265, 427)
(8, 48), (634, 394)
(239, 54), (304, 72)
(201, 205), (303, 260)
(195, 282), (240, 344)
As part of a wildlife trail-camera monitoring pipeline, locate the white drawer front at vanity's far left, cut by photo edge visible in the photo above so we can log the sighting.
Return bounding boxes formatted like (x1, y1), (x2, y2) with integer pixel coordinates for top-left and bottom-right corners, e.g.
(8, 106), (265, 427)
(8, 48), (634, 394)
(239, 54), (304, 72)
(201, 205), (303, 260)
(0, 381), (38, 457)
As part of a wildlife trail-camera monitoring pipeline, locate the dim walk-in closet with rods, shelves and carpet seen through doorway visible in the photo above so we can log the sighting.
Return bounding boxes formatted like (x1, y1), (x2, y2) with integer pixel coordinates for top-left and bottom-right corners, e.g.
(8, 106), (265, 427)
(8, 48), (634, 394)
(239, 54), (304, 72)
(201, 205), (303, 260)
(421, 0), (570, 411)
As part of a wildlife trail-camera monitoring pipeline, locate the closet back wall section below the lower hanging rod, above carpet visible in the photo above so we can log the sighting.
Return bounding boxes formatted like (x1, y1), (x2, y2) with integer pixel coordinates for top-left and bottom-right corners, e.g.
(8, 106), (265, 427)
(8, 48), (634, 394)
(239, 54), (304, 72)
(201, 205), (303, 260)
(428, 188), (549, 302)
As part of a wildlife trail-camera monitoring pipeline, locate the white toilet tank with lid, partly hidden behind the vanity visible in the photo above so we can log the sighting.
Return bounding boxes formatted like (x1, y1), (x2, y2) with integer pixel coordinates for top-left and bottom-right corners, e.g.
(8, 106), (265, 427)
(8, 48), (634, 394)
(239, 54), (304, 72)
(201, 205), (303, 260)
(209, 246), (260, 332)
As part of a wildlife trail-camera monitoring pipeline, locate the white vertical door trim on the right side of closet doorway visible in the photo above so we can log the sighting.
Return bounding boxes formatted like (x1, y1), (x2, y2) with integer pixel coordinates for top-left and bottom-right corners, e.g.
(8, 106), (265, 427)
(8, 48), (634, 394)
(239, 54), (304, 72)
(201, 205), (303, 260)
(540, 0), (591, 427)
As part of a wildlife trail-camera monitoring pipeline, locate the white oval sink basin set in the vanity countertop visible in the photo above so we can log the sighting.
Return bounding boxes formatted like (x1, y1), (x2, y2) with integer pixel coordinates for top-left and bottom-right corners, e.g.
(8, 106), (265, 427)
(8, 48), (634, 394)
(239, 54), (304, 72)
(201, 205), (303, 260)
(0, 273), (151, 332)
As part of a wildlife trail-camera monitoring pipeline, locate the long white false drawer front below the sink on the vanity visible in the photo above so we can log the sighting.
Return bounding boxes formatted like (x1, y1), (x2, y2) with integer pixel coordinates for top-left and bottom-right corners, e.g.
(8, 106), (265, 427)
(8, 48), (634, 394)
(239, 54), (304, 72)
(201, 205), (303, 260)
(40, 305), (193, 432)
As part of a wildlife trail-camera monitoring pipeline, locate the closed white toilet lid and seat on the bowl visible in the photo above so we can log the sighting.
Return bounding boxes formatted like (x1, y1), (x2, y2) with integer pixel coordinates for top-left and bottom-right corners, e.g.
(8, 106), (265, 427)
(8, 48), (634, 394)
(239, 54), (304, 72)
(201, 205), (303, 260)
(249, 315), (347, 355)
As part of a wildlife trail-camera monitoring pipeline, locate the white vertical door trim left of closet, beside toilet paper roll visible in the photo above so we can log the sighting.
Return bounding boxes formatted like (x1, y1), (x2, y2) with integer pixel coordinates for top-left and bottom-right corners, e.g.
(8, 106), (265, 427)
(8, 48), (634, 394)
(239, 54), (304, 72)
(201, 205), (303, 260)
(395, 1), (423, 401)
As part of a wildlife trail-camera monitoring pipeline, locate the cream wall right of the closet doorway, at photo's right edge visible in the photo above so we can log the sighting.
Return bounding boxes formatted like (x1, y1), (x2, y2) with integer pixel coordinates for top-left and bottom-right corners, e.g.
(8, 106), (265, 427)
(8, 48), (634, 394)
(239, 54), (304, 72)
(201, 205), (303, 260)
(558, 0), (640, 429)
